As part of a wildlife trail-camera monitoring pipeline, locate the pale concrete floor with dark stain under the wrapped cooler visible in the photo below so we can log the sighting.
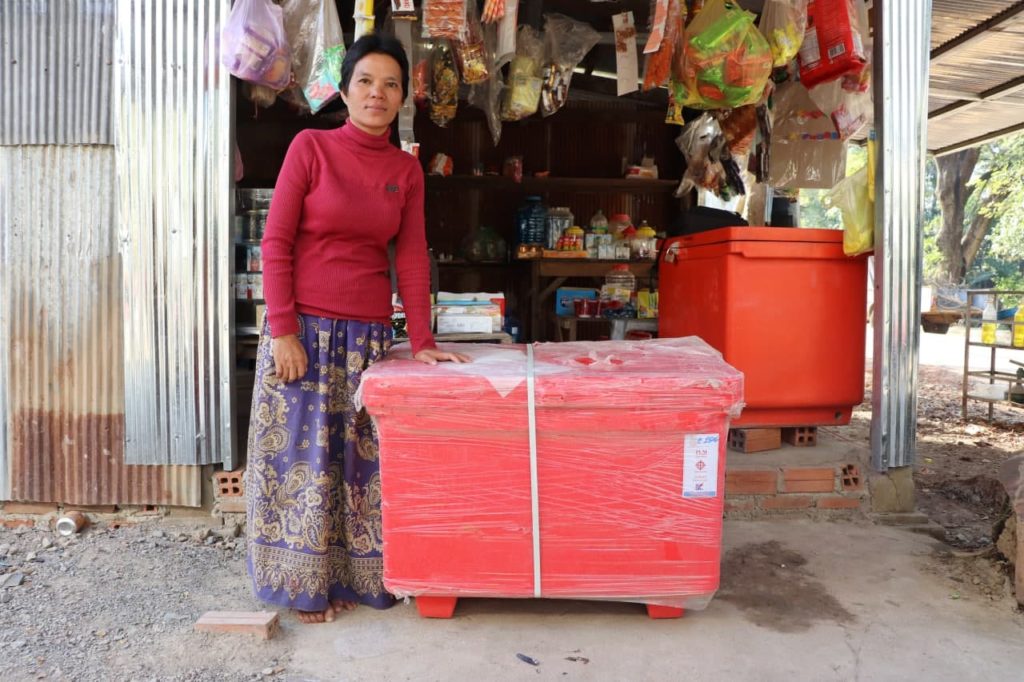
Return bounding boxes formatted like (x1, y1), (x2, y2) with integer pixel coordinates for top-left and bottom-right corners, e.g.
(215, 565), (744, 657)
(282, 520), (1024, 681)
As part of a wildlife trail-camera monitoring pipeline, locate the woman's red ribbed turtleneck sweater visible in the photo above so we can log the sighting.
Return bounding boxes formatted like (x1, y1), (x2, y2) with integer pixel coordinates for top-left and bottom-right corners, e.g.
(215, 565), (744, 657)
(262, 123), (435, 353)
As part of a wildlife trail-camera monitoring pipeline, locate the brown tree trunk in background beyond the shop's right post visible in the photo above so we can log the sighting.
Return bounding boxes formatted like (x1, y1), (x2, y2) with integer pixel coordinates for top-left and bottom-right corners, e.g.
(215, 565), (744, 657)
(935, 147), (980, 284)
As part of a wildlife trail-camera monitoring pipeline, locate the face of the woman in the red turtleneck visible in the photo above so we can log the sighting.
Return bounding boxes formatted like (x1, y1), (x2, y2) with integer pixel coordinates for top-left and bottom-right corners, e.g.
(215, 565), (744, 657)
(341, 52), (402, 135)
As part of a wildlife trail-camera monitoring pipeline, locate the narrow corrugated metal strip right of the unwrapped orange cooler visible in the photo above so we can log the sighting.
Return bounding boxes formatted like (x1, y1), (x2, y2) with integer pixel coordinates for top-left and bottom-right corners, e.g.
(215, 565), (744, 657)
(871, 0), (932, 471)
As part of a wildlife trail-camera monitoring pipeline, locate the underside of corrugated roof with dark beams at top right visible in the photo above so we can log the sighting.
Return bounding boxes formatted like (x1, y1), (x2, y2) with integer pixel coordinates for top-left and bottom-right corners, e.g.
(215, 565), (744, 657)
(928, 0), (1024, 154)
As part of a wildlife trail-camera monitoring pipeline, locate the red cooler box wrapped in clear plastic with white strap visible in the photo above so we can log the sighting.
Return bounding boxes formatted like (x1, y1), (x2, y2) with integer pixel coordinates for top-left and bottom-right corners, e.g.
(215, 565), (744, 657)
(358, 338), (742, 617)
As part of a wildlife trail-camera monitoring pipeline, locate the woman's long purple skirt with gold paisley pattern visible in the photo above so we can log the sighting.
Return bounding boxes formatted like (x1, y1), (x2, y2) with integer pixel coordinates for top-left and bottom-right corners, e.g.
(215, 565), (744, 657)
(246, 314), (394, 611)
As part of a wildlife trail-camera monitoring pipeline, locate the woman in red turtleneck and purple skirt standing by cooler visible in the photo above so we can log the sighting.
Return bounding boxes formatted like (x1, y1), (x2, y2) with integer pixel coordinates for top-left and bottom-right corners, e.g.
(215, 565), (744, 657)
(246, 35), (468, 623)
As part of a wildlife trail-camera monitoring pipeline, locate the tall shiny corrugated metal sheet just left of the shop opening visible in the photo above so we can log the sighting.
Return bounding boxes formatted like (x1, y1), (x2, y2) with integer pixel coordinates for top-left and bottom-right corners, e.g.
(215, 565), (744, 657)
(115, 0), (232, 466)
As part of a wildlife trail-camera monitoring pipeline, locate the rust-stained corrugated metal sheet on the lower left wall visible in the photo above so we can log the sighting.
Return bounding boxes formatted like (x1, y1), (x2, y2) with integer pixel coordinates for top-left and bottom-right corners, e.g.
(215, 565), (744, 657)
(0, 145), (201, 506)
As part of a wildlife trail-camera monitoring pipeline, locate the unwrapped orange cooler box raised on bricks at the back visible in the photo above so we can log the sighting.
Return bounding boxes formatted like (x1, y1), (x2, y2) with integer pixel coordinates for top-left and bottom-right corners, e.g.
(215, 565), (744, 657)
(658, 227), (867, 427)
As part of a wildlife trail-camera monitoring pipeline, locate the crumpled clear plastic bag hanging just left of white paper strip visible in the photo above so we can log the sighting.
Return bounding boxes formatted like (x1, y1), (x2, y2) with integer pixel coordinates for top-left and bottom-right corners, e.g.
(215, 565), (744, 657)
(541, 14), (601, 116)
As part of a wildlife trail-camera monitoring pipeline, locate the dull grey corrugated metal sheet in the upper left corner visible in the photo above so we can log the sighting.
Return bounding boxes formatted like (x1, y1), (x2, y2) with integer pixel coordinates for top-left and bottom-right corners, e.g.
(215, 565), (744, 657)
(0, 0), (114, 145)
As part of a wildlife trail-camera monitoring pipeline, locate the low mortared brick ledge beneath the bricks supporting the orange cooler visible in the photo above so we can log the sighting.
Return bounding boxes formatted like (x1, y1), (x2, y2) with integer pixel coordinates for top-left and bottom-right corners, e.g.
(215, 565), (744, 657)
(725, 464), (865, 513)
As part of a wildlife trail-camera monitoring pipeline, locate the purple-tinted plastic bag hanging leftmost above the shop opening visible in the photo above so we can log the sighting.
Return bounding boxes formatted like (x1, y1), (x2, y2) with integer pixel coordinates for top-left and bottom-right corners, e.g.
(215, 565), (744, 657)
(220, 0), (292, 90)
